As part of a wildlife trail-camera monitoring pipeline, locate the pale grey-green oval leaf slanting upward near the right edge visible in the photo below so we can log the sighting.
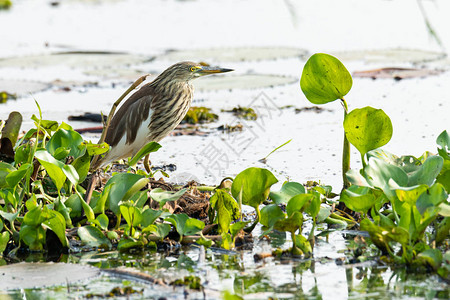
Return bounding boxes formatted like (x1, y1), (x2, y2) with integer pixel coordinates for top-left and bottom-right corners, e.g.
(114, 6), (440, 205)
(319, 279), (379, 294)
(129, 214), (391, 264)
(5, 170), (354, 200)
(408, 155), (444, 186)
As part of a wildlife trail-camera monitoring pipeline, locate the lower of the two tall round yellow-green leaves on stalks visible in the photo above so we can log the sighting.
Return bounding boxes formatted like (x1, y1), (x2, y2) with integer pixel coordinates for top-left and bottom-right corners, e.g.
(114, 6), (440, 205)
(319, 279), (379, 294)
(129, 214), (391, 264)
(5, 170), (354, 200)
(344, 106), (392, 155)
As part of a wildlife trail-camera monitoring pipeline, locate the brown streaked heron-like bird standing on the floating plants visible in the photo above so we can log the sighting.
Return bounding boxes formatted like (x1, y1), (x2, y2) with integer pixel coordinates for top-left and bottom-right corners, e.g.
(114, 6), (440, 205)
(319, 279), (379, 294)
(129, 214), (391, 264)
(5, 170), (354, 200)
(90, 61), (234, 171)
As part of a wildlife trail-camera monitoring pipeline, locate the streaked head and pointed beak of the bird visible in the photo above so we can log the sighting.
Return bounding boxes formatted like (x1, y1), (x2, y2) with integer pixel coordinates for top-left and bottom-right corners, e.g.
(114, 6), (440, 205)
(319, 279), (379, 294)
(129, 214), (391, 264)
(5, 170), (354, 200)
(160, 61), (233, 81)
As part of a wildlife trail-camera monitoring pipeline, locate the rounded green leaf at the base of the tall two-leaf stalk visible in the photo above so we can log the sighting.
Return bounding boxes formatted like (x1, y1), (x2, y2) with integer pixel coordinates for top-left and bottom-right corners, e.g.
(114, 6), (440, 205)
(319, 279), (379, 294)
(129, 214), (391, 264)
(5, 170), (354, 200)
(339, 185), (377, 214)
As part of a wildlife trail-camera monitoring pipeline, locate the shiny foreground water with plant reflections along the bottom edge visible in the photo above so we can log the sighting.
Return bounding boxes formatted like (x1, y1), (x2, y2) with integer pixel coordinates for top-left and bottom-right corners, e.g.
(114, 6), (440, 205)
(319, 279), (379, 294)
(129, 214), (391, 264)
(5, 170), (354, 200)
(0, 233), (450, 299)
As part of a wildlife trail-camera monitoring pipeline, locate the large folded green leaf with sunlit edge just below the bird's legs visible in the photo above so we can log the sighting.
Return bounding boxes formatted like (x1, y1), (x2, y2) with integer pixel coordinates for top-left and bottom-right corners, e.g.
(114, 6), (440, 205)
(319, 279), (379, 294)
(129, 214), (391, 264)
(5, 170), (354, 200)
(105, 173), (149, 215)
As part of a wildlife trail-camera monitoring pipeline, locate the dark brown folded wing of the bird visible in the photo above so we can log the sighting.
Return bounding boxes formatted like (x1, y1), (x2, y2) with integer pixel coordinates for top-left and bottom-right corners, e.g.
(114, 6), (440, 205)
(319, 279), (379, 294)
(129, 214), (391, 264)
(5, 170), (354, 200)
(105, 85), (154, 147)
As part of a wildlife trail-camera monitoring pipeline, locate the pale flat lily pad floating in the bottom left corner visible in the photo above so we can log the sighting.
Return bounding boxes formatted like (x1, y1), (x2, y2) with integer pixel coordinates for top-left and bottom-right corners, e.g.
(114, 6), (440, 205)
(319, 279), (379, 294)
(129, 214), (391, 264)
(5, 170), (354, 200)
(0, 263), (100, 290)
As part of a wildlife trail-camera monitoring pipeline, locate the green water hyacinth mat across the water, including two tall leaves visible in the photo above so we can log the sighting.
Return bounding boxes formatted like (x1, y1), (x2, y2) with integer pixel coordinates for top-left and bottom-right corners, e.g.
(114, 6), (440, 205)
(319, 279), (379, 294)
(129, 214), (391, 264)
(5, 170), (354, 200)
(0, 54), (450, 298)
